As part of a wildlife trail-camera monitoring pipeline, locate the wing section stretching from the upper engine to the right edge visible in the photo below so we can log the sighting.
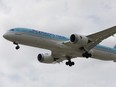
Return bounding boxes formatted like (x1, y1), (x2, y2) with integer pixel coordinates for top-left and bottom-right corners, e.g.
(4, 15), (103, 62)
(85, 26), (116, 50)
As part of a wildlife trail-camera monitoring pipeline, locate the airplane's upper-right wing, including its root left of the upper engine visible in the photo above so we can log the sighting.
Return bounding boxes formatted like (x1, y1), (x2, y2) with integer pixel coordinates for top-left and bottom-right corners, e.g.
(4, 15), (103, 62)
(63, 26), (116, 51)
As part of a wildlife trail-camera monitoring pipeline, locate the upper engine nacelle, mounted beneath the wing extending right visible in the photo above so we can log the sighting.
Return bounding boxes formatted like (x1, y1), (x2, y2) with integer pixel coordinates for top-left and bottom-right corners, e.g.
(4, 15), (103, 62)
(70, 34), (89, 46)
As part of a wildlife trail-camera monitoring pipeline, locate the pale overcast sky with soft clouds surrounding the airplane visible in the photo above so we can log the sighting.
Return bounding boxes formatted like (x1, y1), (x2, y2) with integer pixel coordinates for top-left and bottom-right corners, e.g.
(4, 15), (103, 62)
(0, 0), (116, 87)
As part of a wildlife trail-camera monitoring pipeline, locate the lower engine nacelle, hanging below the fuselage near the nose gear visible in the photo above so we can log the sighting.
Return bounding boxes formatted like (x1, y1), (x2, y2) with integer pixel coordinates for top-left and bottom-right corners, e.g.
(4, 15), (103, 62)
(38, 54), (54, 63)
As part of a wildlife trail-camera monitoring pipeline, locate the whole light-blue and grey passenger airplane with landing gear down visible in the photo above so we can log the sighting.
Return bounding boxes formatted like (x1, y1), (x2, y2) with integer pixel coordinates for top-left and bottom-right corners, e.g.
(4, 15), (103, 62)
(3, 26), (116, 67)
